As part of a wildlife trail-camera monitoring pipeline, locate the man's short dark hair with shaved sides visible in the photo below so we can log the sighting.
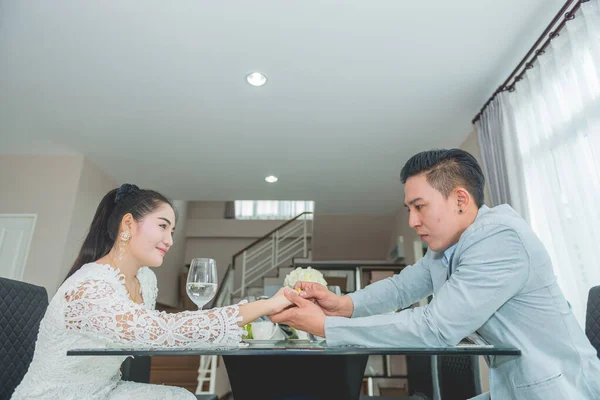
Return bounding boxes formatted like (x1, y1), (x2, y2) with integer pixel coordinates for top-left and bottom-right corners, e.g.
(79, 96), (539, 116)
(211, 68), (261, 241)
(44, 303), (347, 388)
(400, 149), (485, 208)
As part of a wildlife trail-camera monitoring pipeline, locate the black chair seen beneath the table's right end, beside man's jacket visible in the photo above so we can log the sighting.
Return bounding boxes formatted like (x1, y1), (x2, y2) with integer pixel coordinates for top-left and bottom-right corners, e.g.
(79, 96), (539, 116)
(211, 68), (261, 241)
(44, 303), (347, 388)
(437, 356), (481, 400)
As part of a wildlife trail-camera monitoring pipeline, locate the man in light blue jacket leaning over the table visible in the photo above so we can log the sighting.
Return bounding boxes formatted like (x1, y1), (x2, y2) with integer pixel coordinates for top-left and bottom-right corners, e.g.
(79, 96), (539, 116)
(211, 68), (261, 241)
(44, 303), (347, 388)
(271, 149), (600, 400)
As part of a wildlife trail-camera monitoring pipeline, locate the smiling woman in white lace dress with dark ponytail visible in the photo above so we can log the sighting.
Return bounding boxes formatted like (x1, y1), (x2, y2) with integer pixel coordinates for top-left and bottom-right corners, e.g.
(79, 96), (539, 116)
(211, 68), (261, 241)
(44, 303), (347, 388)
(12, 184), (290, 400)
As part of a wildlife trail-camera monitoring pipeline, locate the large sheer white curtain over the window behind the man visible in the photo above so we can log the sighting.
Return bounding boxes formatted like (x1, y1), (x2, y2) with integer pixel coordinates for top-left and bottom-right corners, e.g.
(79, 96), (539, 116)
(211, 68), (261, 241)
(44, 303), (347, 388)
(501, 0), (600, 325)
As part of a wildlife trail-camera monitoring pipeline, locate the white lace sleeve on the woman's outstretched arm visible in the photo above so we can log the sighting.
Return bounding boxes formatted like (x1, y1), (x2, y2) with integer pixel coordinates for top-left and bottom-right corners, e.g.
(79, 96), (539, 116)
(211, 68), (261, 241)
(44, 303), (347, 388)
(64, 280), (244, 347)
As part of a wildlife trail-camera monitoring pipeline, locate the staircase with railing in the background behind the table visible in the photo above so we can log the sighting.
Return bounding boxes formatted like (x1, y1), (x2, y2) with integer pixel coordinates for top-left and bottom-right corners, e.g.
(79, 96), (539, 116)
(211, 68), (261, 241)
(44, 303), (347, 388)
(195, 212), (312, 394)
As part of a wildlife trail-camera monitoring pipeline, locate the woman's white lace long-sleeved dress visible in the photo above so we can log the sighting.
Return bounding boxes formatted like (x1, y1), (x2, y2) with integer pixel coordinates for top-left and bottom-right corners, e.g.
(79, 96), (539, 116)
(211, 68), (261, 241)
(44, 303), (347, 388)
(12, 263), (243, 400)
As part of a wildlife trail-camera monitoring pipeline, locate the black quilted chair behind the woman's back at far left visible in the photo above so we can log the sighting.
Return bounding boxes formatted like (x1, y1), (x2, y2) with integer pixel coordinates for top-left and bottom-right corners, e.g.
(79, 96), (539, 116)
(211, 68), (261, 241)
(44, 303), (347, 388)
(0, 278), (48, 400)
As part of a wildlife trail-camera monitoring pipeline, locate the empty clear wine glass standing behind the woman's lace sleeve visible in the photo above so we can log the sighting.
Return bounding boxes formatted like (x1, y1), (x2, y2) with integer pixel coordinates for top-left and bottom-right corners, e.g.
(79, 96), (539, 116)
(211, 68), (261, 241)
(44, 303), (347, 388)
(185, 258), (217, 310)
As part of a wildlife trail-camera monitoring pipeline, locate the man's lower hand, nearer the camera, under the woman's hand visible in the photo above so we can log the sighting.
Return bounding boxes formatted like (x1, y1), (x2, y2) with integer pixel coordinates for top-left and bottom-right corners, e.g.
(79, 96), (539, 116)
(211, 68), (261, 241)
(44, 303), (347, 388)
(269, 291), (325, 337)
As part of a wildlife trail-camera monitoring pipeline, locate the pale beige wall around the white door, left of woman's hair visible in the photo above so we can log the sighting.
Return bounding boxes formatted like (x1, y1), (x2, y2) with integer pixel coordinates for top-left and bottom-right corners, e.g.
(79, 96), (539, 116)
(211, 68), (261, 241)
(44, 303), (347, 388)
(0, 155), (117, 296)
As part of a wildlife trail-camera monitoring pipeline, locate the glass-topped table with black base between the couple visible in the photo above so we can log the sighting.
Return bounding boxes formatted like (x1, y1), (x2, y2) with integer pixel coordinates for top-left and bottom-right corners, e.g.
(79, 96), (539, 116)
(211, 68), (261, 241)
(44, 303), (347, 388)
(67, 340), (521, 400)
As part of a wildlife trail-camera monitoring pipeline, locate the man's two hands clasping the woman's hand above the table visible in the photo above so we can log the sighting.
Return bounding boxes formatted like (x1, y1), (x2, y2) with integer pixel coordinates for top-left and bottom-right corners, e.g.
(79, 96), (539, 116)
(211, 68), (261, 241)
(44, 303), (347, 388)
(269, 282), (354, 337)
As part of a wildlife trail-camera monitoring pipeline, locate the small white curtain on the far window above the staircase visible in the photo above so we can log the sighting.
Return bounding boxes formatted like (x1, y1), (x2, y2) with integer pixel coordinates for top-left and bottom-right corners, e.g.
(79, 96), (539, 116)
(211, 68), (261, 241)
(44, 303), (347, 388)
(235, 200), (315, 219)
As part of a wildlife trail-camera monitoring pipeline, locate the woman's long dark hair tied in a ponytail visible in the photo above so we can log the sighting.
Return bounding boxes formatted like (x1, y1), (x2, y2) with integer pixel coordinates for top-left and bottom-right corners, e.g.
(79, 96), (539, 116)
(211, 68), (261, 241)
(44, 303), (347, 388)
(65, 183), (177, 279)
